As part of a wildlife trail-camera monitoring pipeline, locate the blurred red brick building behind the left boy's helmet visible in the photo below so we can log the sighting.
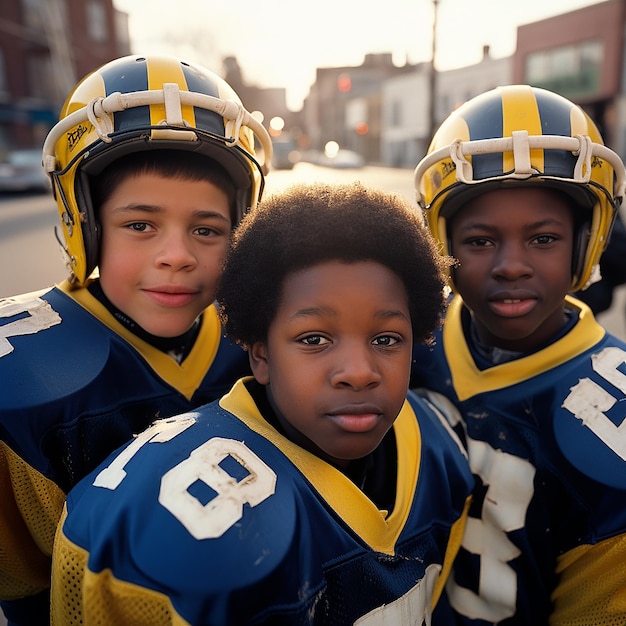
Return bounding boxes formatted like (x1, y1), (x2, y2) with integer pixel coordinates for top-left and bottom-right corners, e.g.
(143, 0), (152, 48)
(0, 0), (130, 150)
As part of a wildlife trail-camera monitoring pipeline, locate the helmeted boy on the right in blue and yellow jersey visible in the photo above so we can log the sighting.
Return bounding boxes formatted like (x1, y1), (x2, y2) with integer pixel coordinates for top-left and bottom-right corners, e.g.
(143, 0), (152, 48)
(413, 85), (626, 626)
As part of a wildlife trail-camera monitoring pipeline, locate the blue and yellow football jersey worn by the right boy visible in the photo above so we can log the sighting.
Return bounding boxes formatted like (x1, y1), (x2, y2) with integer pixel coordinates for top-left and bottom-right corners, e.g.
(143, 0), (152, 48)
(413, 296), (626, 626)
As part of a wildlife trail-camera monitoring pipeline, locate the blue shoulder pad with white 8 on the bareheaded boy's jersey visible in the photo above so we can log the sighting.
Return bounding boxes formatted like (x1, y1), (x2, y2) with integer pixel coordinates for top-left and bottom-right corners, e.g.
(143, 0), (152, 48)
(64, 402), (302, 601)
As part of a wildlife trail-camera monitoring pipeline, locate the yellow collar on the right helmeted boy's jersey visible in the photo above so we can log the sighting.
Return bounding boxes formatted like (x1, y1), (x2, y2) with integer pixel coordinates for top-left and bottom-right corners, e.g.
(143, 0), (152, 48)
(443, 295), (606, 401)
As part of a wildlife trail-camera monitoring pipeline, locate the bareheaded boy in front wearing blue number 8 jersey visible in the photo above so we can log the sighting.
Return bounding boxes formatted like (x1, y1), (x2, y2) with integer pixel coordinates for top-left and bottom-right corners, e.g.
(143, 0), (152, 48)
(52, 184), (474, 626)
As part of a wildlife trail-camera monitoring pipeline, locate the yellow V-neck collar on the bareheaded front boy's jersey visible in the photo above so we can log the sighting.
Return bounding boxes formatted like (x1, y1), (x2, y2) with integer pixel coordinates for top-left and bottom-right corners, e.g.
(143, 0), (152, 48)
(220, 379), (421, 554)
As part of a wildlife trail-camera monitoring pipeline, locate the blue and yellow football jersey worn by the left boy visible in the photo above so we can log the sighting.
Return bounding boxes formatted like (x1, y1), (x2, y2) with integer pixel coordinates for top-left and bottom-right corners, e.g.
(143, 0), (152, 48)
(0, 283), (250, 626)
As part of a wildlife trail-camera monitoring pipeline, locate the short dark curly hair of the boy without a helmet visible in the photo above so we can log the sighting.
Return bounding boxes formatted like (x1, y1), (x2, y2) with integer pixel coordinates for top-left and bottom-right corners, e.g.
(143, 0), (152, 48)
(217, 183), (450, 346)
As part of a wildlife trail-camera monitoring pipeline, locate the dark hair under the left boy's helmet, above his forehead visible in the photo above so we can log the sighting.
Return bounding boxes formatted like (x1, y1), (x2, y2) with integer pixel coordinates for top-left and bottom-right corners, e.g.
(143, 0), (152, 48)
(89, 149), (236, 219)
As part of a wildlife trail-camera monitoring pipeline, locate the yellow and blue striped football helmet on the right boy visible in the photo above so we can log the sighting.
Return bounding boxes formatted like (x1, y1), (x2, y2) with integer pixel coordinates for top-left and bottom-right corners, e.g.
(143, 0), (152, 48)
(414, 85), (626, 291)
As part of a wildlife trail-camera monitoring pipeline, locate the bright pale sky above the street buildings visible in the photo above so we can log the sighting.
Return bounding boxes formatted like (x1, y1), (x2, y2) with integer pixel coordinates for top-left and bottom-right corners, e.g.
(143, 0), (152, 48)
(113, 0), (600, 110)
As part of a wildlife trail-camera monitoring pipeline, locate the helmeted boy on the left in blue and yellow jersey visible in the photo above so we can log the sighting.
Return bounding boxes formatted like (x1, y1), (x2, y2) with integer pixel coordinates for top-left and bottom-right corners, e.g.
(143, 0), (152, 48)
(0, 56), (271, 625)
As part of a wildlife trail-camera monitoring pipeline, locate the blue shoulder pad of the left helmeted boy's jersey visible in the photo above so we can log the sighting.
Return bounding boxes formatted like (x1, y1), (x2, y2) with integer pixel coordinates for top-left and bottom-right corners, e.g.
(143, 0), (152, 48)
(0, 287), (109, 410)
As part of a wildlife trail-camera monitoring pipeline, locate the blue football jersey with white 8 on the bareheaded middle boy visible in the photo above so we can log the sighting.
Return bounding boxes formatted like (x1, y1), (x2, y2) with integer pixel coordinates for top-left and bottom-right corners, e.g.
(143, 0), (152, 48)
(52, 379), (473, 626)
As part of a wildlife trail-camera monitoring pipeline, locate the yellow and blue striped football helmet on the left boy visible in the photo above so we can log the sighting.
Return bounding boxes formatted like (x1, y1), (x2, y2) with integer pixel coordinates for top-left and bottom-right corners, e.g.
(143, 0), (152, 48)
(43, 55), (272, 284)
